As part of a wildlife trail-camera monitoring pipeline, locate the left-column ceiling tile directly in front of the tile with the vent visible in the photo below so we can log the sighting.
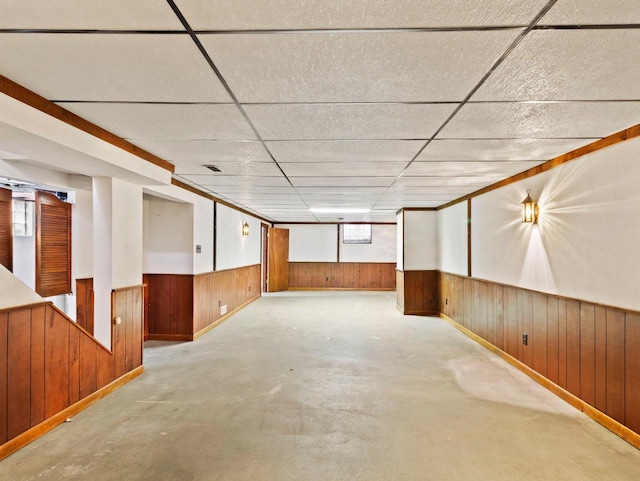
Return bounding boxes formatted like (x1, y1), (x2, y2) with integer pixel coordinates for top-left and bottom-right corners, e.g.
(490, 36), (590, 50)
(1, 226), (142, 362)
(136, 141), (273, 168)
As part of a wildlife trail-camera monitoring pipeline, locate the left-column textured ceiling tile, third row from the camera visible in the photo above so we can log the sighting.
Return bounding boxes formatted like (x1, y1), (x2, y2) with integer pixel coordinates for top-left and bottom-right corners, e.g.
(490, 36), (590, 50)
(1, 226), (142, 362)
(55, 103), (255, 142)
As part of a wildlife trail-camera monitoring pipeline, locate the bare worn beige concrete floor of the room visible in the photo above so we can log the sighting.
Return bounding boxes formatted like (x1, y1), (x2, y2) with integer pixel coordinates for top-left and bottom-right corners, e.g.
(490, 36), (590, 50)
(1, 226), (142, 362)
(0, 292), (640, 481)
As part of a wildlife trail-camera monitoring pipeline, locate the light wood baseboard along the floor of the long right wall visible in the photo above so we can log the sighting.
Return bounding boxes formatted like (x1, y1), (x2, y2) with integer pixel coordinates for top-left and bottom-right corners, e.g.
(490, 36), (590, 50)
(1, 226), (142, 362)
(439, 313), (640, 449)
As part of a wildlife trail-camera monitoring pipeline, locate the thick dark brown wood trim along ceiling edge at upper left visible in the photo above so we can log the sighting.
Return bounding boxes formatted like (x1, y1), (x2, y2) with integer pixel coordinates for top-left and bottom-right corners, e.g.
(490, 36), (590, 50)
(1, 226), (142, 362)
(0, 75), (175, 173)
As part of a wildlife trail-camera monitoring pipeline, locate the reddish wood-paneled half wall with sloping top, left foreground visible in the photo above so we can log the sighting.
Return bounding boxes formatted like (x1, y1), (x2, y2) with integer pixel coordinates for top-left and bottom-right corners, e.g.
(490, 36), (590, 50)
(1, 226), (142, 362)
(0, 286), (143, 459)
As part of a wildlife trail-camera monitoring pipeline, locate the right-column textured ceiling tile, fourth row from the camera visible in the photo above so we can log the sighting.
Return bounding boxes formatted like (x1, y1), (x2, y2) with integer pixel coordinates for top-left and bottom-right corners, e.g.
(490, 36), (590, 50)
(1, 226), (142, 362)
(416, 139), (596, 161)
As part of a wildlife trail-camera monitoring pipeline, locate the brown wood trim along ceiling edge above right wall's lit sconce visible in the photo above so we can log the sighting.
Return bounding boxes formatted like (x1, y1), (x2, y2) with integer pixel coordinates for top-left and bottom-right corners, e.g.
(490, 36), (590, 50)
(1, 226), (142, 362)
(436, 124), (640, 210)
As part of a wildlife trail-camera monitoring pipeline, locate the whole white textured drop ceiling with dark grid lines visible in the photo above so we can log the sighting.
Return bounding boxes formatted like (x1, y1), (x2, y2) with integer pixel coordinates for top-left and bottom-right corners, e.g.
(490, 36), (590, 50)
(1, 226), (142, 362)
(0, 0), (640, 222)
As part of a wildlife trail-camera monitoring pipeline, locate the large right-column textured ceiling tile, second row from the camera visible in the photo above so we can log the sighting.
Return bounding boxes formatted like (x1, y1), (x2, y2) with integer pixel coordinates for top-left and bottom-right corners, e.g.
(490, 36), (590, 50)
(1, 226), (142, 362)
(473, 30), (640, 100)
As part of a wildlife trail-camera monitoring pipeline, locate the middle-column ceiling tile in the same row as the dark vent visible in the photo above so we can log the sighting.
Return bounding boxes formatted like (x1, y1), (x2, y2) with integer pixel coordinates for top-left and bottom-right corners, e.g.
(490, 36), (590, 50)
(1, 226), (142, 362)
(281, 162), (407, 177)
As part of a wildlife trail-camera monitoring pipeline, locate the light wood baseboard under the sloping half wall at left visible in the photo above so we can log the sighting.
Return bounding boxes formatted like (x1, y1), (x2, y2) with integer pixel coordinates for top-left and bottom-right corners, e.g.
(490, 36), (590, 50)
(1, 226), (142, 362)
(0, 366), (144, 461)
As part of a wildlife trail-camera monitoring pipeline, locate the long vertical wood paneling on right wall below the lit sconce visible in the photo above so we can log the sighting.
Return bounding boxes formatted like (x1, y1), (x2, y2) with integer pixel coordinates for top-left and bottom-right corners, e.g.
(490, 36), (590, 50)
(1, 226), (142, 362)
(440, 273), (640, 433)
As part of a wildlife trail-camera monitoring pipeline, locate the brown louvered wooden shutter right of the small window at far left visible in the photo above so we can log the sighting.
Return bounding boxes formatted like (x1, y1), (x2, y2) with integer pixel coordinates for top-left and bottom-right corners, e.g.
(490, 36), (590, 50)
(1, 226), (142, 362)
(36, 192), (71, 297)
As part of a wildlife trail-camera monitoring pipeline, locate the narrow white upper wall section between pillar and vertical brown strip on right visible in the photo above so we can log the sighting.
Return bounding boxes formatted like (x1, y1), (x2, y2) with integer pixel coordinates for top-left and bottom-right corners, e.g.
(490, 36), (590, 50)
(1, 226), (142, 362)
(437, 202), (467, 276)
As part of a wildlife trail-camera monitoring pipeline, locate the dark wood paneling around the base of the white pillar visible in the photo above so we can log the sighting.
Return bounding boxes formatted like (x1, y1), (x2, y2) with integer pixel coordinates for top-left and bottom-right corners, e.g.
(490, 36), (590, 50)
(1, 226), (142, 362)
(396, 270), (440, 316)
